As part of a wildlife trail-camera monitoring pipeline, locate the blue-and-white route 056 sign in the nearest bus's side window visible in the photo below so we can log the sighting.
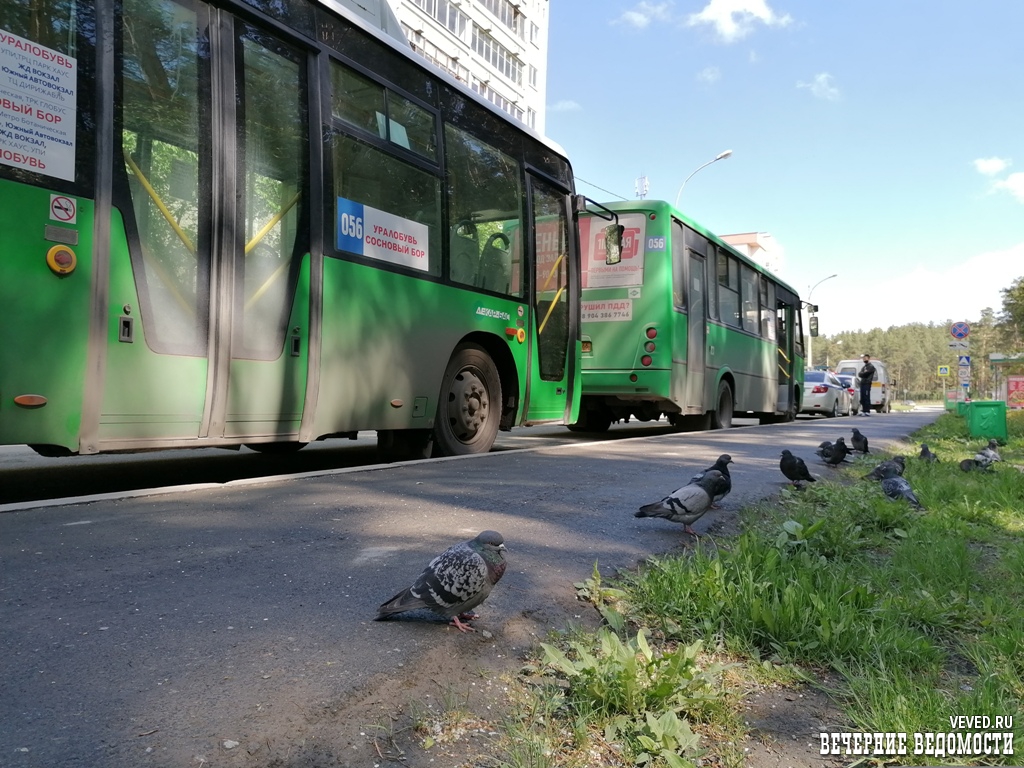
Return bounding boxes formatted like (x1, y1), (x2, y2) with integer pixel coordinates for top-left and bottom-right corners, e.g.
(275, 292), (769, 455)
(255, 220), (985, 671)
(337, 198), (430, 271)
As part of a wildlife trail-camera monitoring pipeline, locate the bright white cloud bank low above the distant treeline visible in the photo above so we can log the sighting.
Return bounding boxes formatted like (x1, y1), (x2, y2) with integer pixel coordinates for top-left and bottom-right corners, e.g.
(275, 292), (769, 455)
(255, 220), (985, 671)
(802, 241), (1024, 336)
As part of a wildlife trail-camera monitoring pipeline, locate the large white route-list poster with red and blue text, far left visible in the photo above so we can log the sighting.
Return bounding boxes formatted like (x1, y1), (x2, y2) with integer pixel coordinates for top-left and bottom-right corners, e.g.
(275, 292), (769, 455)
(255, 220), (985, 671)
(0, 30), (78, 181)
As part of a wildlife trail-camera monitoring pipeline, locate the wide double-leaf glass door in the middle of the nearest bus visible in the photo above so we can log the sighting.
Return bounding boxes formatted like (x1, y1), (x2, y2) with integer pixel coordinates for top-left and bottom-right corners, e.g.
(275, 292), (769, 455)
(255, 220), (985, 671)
(107, 0), (309, 446)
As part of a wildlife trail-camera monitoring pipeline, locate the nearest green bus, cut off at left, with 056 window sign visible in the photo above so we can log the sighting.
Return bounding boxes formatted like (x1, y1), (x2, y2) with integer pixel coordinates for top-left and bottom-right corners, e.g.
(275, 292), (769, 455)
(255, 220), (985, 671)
(0, 0), (614, 458)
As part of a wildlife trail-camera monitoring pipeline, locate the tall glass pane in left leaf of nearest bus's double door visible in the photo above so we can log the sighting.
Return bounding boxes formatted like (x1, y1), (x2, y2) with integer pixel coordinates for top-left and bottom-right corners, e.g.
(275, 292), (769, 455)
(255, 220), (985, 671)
(120, 0), (211, 355)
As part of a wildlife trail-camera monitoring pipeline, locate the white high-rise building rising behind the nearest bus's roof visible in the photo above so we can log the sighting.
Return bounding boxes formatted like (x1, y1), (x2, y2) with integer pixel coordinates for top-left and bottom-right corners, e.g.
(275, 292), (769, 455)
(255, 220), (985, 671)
(390, 0), (548, 134)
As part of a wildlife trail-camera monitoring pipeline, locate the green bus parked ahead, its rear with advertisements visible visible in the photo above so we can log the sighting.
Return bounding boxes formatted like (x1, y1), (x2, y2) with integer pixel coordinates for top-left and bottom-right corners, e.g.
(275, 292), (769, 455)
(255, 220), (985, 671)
(570, 200), (804, 432)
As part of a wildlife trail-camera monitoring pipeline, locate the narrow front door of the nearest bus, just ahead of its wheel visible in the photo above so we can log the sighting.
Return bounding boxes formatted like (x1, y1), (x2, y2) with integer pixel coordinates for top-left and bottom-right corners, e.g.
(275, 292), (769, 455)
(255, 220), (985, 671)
(525, 175), (580, 424)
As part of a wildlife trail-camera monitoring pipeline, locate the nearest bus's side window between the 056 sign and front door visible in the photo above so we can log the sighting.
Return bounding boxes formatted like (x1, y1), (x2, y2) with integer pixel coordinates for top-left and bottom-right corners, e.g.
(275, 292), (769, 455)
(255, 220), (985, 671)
(444, 125), (523, 297)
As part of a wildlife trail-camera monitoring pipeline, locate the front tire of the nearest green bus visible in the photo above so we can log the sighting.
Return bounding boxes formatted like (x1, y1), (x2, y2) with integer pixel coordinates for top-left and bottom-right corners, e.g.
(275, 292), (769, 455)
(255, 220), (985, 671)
(434, 344), (502, 456)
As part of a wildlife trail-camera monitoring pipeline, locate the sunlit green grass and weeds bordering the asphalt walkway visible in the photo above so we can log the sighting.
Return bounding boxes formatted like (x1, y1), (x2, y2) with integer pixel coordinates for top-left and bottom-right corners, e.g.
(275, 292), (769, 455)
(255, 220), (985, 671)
(506, 414), (1024, 768)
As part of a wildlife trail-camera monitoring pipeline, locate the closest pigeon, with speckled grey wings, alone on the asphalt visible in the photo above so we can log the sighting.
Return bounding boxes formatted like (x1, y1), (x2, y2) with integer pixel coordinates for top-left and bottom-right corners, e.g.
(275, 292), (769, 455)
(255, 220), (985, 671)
(374, 530), (506, 632)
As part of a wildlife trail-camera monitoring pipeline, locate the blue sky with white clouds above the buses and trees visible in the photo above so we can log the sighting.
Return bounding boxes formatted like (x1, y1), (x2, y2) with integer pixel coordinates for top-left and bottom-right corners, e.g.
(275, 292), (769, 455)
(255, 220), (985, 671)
(546, 0), (1024, 334)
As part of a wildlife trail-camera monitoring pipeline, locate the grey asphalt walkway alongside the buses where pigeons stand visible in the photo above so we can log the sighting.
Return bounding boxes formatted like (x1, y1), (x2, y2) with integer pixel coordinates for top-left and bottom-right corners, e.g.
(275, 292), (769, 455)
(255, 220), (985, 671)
(0, 411), (940, 768)
